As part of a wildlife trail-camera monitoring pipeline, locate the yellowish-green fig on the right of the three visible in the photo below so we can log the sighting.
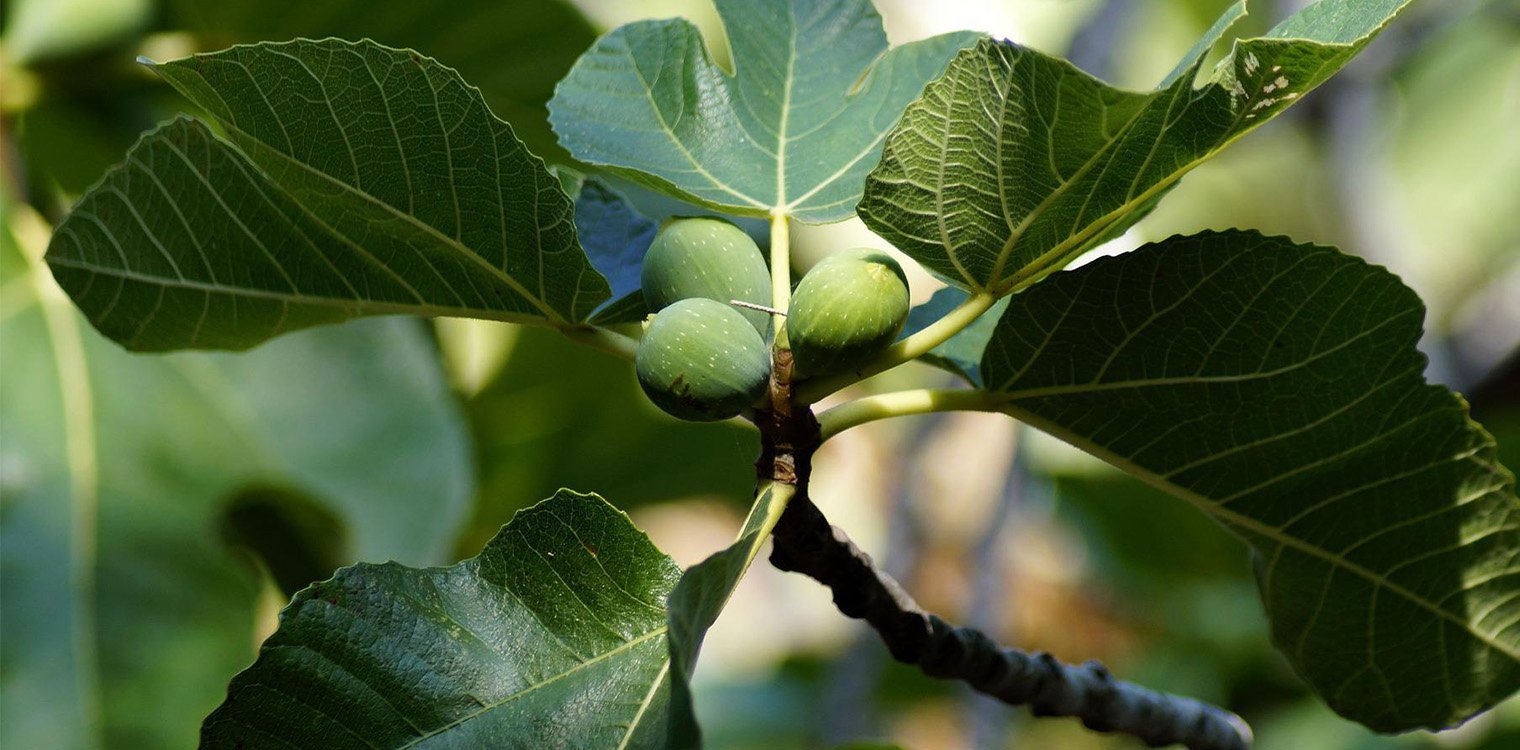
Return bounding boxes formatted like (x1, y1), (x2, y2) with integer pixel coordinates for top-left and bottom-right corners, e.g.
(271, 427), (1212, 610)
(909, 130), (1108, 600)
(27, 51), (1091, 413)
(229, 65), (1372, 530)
(786, 248), (909, 377)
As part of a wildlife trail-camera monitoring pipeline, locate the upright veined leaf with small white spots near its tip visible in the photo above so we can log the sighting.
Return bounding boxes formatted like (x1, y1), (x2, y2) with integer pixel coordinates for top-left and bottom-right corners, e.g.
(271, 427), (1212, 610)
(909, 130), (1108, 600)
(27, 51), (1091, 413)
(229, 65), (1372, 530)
(859, 0), (1408, 294)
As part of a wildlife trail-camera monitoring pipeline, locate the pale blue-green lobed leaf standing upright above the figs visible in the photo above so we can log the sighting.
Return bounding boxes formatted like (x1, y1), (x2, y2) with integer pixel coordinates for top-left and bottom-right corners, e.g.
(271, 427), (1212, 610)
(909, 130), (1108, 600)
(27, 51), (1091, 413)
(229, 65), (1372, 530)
(549, 0), (977, 222)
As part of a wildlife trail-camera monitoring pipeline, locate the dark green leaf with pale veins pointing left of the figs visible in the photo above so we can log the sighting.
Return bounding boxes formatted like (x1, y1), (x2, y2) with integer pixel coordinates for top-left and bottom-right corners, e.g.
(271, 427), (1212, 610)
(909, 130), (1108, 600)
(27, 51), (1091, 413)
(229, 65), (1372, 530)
(47, 40), (608, 350)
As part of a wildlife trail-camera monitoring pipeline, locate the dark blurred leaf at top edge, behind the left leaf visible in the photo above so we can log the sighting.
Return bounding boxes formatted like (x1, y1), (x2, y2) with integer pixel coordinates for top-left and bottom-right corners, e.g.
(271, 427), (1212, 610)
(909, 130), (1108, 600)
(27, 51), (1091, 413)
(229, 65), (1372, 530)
(167, 0), (596, 158)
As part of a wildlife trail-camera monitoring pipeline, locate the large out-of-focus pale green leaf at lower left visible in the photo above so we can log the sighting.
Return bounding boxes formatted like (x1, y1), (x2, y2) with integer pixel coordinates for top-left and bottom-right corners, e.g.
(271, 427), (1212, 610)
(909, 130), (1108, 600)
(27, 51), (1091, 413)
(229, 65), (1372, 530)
(0, 205), (473, 750)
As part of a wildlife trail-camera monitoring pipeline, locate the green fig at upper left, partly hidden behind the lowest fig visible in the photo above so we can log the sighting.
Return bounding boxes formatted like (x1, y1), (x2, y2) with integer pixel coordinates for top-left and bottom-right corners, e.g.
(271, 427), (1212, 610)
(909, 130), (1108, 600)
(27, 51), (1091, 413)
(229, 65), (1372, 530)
(640, 218), (771, 335)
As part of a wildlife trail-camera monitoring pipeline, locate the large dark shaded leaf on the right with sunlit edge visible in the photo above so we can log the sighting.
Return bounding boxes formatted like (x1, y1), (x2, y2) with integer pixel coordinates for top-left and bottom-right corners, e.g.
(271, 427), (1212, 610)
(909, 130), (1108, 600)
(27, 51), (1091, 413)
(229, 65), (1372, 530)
(982, 231), (1520, 732)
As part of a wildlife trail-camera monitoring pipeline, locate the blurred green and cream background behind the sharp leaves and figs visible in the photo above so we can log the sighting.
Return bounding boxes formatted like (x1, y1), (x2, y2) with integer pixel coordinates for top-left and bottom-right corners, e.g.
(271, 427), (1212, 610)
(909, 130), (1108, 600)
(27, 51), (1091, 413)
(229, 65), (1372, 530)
(0, 0), (1520, 750)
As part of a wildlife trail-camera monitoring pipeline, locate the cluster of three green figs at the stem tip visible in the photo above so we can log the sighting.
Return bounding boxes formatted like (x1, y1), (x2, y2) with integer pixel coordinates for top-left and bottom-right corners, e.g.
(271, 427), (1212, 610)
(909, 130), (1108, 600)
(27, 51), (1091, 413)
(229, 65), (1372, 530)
(635, 218), (909, 421)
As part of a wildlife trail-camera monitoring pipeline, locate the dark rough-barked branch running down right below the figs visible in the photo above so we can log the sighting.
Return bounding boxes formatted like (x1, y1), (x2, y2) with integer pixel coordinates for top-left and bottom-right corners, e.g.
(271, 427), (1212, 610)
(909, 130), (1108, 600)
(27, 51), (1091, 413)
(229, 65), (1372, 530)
(771, 489), (1251, 750)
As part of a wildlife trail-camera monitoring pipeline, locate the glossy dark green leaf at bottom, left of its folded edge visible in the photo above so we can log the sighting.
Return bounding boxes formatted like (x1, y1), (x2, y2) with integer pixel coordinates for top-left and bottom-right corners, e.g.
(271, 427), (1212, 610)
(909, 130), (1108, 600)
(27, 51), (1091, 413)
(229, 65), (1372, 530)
(202, 490), (679, 750)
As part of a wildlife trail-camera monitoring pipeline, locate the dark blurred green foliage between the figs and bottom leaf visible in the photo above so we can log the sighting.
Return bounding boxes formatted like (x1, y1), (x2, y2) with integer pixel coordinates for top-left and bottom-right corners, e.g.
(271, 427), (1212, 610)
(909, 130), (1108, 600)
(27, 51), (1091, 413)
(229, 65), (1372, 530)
(461, 329), (757, 552)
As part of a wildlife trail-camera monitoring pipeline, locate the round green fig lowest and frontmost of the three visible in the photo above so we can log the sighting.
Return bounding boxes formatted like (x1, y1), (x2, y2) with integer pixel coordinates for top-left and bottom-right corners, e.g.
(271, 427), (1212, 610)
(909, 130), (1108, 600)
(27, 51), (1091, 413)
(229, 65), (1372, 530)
(634, 297), (771, 421)
